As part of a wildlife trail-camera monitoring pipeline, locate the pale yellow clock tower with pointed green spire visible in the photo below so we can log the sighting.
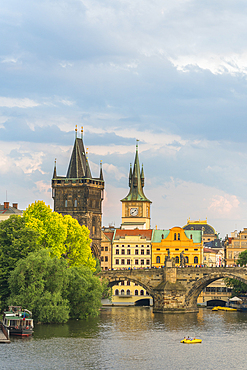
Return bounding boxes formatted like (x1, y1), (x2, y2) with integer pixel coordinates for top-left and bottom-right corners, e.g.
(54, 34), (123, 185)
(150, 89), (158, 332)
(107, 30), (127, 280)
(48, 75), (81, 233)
(121, 145), (152, 229)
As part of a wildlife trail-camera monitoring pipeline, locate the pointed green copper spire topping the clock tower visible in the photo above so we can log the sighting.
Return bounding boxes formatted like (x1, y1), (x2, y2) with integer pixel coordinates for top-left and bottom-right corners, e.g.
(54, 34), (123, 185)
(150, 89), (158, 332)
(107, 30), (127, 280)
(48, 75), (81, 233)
(122, 140), (151, 203)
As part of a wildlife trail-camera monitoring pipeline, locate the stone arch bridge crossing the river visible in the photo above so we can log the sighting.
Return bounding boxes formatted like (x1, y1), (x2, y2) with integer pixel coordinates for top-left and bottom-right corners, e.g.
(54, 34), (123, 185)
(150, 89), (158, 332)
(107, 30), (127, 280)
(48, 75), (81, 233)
(101, 267), (247, 313)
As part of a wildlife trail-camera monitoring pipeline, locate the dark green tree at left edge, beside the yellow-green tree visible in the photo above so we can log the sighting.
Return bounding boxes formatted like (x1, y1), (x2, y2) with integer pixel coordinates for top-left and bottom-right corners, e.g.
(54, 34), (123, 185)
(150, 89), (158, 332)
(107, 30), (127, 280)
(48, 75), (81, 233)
(0, 215), (39, 305)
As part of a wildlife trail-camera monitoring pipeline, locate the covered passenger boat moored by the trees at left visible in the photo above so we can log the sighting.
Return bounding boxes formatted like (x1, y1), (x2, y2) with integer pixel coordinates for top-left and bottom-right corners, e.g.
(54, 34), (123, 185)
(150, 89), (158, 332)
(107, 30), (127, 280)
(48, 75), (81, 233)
(2, 306), (34, 337)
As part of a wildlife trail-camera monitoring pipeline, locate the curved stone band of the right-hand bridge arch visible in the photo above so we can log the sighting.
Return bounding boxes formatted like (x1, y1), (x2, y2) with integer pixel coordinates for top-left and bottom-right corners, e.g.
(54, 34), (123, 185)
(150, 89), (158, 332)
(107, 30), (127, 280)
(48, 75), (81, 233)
(185, 271), (247, 307)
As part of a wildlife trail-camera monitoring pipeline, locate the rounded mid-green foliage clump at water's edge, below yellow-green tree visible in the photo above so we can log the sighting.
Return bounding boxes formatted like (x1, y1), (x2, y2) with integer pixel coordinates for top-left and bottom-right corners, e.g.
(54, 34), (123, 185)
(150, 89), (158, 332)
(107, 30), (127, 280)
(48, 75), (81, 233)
(9, 249), (103, 323)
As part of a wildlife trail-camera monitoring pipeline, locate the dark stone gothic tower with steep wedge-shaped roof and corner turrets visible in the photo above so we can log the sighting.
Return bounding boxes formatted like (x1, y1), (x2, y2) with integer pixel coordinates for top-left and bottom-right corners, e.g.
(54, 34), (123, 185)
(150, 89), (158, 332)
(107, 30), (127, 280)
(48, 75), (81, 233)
(52, 128), (104, 258)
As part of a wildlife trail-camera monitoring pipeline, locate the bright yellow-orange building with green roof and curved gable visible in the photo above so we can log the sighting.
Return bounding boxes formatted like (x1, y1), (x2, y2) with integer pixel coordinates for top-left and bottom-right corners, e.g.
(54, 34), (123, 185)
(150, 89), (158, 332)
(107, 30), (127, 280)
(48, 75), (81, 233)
(152, 227), (203, 267)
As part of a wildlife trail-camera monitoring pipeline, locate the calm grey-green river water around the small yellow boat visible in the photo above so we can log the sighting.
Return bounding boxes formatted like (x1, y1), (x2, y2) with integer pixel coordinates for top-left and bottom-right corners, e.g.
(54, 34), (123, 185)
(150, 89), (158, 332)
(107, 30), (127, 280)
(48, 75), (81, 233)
(0, 307), (247, 370)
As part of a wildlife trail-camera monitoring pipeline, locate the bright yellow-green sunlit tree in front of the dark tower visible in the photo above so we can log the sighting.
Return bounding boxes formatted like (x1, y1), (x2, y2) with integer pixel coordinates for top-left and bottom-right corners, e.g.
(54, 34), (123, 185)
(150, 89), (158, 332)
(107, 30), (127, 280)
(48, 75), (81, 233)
(23, 201), (96, 271)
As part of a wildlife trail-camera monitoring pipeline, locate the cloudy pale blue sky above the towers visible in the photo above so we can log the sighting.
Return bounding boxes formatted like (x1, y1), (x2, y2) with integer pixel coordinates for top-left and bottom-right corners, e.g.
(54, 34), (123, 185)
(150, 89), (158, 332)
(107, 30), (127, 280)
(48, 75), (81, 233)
(0, 0), (247, 238)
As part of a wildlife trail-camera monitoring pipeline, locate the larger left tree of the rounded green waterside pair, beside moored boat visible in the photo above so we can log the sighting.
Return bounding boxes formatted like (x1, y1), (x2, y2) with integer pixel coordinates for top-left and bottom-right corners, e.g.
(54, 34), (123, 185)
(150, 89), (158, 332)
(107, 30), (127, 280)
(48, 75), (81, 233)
(8, 249), (70, 323)
